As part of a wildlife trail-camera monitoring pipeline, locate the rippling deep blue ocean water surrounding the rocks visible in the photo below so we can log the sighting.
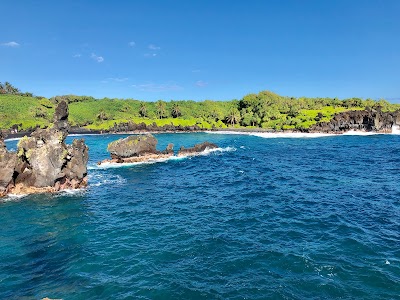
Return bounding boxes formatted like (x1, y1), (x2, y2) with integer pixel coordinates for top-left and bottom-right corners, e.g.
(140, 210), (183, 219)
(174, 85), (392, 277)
(0, 133), (400, 299)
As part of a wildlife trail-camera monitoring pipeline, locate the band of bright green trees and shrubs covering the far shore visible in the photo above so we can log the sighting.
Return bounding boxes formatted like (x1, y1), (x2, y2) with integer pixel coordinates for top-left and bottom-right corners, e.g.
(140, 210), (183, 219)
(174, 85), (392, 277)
(0, 83), (400, 130)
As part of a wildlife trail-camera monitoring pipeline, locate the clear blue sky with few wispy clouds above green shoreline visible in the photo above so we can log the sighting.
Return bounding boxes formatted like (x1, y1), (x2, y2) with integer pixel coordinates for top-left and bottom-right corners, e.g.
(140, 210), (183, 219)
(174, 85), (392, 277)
(0, 0), (400, 102)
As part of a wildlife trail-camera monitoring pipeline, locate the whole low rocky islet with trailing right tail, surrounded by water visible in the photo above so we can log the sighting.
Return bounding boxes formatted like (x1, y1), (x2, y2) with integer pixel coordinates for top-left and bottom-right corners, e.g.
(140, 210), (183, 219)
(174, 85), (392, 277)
(97, 134), (218, 165)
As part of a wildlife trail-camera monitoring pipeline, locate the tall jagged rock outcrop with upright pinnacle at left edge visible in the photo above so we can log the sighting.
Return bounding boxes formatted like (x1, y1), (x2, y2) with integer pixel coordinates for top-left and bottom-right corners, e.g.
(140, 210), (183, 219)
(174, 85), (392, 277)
(0, 101), (89, 196)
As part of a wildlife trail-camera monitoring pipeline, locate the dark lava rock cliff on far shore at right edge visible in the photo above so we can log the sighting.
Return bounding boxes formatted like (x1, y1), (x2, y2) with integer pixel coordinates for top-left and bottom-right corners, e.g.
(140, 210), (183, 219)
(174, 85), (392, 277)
(309, 110), (400, 133)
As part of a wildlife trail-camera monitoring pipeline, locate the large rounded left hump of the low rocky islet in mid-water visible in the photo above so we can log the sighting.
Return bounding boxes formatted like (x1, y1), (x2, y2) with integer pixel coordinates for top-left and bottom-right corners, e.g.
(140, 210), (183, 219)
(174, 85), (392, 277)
(98, 134), (174, 165)
